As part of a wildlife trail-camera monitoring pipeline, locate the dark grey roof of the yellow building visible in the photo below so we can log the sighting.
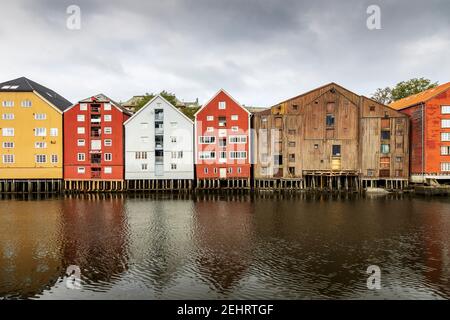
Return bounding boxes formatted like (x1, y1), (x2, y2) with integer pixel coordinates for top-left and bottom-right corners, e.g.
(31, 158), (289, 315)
(0, 77), (72, 111)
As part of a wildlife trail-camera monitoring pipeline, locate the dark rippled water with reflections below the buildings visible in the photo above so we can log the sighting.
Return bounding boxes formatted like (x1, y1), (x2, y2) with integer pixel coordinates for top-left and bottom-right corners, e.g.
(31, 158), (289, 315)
(0, 195), (450, 299)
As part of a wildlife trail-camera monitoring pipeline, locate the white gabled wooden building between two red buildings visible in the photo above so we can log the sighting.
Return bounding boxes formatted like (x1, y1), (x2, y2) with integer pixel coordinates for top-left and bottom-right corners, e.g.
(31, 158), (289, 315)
(124, 95), (194, 181)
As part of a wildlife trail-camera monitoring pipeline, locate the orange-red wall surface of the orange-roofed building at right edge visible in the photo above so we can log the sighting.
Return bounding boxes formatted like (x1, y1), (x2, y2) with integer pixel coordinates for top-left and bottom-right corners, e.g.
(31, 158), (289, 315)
(401, 90), (450, 174)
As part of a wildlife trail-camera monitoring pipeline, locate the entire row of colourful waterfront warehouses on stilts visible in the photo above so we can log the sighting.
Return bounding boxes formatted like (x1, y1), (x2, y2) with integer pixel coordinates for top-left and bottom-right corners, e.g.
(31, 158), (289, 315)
(0, 77), (450, 193)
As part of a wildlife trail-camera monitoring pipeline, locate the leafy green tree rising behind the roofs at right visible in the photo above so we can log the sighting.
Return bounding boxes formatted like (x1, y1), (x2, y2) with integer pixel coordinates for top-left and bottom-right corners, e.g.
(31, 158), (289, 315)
(372, 77), (438, 104)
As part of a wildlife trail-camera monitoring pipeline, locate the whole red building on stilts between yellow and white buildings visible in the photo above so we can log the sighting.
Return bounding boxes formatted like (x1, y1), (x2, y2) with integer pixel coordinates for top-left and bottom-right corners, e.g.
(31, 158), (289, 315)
(64, 94), (131, 191)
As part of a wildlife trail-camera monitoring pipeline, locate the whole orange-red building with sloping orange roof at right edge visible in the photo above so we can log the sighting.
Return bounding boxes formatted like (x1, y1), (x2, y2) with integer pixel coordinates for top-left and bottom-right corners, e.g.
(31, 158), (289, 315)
(390, 82), (450, 182)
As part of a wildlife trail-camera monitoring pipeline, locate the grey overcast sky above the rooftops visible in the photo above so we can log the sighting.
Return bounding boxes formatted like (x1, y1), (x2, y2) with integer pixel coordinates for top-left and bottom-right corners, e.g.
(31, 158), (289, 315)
(0, 0), (450, 106)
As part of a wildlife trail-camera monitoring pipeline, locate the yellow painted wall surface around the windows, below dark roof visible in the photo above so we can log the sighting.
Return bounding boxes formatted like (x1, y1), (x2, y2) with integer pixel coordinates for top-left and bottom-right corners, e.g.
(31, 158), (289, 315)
(0, 92), (63, 179)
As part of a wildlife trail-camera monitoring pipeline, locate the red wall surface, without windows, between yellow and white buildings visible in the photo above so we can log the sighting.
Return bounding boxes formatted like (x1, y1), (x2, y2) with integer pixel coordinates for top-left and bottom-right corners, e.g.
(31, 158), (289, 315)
(64, 98), (129, 180)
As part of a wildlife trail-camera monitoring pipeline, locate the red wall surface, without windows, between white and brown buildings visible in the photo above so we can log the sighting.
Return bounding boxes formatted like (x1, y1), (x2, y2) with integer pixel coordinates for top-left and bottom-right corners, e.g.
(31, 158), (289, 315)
(195, 91), (250, 179)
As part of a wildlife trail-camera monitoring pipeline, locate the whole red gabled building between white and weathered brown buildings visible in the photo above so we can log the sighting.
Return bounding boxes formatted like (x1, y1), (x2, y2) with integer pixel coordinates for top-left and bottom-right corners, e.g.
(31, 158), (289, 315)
(195, 90), (251, 188)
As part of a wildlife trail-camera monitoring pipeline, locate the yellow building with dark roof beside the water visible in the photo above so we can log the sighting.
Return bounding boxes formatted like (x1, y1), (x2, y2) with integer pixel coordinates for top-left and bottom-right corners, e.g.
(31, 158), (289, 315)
(0, 77), (71, 179)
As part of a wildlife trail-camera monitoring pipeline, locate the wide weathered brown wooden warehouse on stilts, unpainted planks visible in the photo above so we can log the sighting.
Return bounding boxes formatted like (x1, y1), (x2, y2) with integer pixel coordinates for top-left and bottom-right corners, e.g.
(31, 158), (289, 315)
(253, 83), (409, 190)
